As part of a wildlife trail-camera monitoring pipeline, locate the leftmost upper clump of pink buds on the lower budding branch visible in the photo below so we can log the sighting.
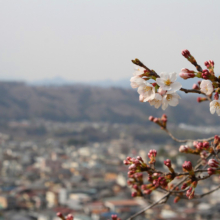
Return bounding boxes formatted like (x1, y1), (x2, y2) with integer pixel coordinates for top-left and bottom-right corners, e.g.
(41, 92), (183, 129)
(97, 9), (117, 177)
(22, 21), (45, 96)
(124, 156), (149, 174)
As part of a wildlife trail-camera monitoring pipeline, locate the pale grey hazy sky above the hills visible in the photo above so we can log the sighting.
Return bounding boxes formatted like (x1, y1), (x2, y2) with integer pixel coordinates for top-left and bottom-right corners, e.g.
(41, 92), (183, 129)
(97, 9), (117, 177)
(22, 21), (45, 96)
(0, 0), (220, 81)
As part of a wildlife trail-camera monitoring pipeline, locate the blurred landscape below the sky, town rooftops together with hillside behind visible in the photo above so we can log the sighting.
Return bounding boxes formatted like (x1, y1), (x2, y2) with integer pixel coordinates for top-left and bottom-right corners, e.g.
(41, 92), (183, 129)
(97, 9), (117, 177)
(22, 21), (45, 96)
(0, 83), (220, 220)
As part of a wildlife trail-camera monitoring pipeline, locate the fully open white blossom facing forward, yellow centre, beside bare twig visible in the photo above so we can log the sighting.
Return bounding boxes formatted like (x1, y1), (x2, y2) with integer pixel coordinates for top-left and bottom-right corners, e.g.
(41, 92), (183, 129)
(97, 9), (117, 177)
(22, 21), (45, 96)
(156, 73), (182, 92)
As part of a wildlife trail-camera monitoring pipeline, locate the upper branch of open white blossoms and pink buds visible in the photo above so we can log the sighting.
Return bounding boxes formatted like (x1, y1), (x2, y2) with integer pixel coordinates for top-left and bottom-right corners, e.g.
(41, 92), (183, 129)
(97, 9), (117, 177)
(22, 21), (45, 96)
(130, 50), (220, 116)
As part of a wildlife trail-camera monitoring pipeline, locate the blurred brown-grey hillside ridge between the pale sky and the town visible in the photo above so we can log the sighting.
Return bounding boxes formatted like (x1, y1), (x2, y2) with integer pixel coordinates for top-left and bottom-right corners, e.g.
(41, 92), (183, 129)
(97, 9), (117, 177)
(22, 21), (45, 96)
(0, 82), (220, 125)
